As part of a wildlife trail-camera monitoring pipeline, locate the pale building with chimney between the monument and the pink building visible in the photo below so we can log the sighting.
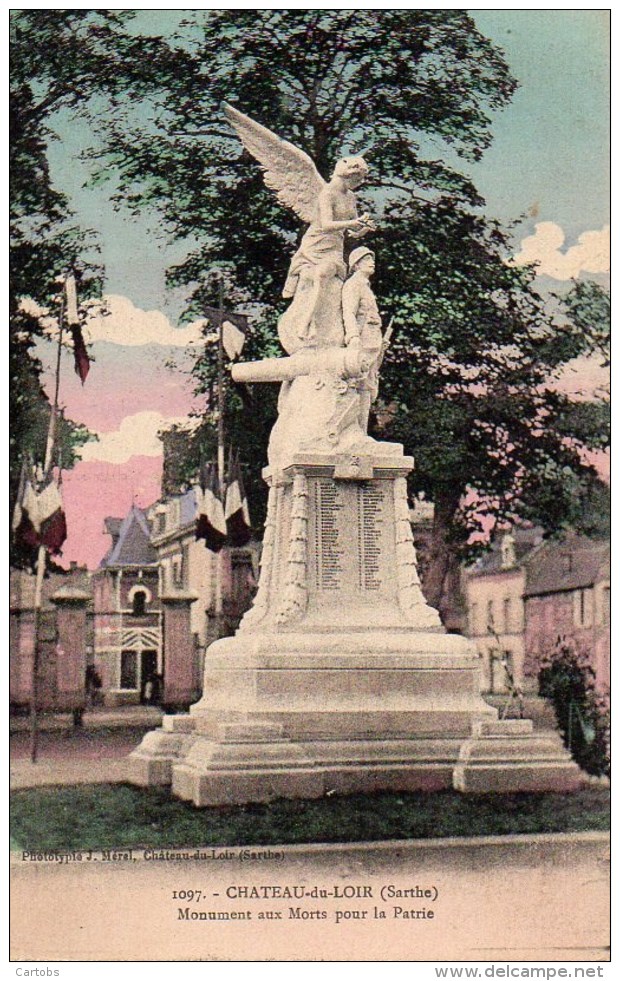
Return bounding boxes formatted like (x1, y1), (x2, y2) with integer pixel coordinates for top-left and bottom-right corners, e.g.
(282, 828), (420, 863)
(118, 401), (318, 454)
(463, 527), (542, 694)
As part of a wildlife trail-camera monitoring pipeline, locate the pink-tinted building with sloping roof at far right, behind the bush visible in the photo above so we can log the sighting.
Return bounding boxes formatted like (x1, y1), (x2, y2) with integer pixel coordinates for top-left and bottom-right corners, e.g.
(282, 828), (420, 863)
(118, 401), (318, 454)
(524, 534), (610, 690)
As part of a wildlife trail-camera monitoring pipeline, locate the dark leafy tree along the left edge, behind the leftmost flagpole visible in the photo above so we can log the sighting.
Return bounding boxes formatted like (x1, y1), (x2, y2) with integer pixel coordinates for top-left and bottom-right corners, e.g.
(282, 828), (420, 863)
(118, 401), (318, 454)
(9, 10), (170, 564)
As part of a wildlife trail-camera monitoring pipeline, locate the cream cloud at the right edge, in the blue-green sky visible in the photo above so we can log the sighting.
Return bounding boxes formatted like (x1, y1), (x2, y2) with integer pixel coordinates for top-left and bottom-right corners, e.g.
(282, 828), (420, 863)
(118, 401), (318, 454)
(513, 221), (610, 280)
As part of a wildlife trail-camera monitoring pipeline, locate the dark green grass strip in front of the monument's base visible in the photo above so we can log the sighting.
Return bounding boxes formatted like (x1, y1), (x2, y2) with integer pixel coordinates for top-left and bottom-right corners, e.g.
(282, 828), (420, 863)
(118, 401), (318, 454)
(11, 784), (610, 851)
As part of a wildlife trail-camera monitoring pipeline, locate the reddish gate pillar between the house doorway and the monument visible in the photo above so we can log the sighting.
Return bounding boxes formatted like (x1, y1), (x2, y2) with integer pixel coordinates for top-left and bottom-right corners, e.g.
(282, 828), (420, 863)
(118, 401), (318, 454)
(161, 593), (198, 706)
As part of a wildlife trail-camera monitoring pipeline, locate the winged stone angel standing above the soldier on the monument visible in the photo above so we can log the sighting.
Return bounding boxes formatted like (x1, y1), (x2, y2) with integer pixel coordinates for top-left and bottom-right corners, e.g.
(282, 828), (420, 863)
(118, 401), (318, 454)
(224, 104), (374, 354)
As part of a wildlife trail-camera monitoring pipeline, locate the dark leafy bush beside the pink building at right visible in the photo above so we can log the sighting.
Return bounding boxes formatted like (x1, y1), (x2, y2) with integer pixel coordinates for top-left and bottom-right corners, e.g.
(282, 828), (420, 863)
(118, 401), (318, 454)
(538, 637), (610, 776)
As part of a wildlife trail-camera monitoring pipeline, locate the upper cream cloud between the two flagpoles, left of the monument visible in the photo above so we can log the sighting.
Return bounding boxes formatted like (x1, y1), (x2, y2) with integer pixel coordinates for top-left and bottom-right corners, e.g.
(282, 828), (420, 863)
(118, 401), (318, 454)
(86, 294), (212, 347)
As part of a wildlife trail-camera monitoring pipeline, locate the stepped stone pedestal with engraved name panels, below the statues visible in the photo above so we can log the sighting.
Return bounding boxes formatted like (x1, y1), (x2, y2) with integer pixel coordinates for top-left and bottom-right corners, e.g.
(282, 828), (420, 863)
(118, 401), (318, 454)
(131, 439), (579, 807)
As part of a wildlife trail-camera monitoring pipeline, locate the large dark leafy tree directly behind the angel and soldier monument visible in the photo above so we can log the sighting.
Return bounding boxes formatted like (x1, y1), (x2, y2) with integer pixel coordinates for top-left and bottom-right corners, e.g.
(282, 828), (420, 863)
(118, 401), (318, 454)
(89, 10), (605, 605)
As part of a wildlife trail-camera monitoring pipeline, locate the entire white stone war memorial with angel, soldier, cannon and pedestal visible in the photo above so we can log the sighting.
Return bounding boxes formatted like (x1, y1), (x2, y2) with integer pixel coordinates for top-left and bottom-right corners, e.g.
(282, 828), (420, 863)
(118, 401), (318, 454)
(130, 106), (581, 807)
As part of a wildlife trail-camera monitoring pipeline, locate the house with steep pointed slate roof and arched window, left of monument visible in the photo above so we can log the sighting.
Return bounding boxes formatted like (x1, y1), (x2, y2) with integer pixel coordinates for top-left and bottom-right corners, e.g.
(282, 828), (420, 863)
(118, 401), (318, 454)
(93, 489), (259, 705)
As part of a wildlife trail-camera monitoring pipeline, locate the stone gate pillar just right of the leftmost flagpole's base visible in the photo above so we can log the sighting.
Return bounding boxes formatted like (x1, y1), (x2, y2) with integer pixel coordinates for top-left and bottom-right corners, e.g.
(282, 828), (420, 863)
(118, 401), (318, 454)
(51, 586), (90, 711)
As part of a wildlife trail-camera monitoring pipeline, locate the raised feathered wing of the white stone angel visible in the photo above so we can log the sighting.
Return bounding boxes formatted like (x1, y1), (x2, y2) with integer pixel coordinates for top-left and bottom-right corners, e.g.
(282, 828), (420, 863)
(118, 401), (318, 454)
(224, 102), (325, 224)
